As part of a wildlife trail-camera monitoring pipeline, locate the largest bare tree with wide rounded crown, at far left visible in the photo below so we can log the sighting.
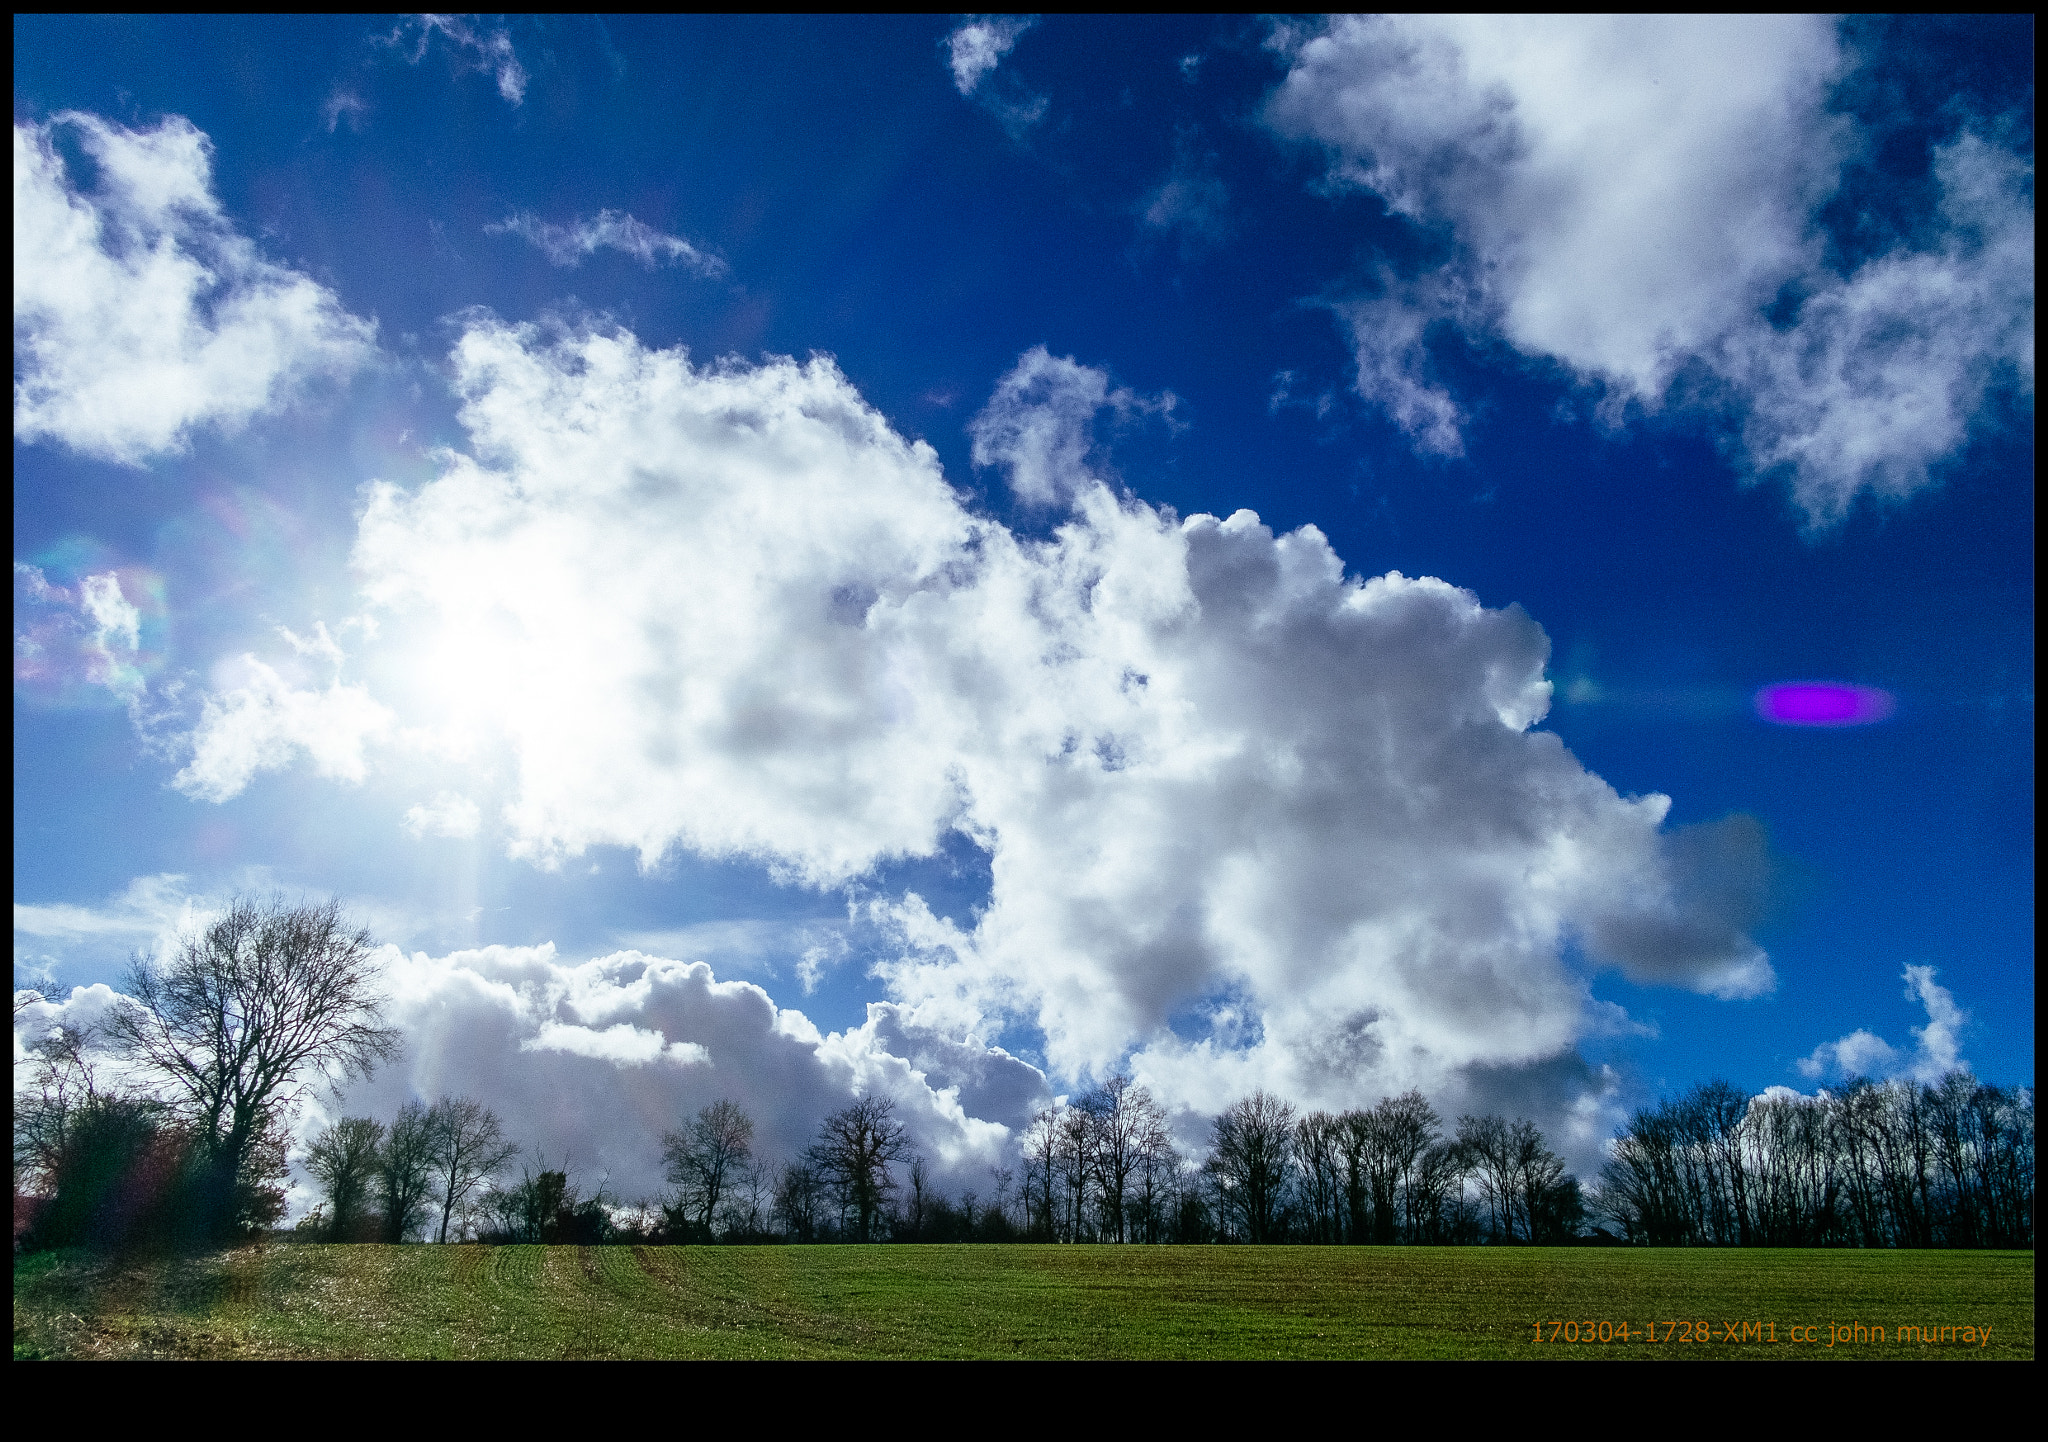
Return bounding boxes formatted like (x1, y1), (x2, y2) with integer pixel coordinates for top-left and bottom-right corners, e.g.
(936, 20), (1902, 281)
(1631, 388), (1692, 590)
(106, 897), (397, 1231)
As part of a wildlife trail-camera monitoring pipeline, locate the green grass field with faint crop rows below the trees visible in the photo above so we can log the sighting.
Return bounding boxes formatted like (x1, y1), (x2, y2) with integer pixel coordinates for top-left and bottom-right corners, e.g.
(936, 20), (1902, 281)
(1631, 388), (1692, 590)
(14, 1245), (2034, 1360)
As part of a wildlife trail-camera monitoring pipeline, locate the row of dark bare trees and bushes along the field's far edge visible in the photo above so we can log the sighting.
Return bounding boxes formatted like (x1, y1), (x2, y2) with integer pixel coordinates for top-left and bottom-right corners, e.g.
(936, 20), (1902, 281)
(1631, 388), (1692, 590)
(14, 897), (2034, 1247)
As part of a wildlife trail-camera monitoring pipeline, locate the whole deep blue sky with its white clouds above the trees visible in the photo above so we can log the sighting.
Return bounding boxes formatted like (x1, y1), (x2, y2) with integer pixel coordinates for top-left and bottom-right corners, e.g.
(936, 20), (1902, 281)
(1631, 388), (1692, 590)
(14, 16), (2034, 1204)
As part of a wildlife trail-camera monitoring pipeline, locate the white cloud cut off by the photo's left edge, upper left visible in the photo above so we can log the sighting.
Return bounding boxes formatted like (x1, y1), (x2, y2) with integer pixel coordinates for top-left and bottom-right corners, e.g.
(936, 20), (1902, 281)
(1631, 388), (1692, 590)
(14, 111), (375, 465)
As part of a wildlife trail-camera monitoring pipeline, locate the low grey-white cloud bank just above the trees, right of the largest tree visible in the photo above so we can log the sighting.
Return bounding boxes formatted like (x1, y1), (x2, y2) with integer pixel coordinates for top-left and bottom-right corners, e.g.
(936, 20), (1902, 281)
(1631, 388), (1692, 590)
(301, 946), (1051, 1200)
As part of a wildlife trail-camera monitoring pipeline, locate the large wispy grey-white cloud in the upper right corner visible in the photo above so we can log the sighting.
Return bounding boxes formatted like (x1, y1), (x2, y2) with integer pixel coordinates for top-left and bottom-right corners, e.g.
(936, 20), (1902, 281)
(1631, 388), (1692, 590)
(1266, 16), (2034, 526)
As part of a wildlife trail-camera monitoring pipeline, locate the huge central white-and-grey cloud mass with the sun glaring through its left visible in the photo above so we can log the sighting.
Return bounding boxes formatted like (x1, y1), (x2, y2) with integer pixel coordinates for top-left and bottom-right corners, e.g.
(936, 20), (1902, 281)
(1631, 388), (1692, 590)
(260, 317), (1772, 1138)
